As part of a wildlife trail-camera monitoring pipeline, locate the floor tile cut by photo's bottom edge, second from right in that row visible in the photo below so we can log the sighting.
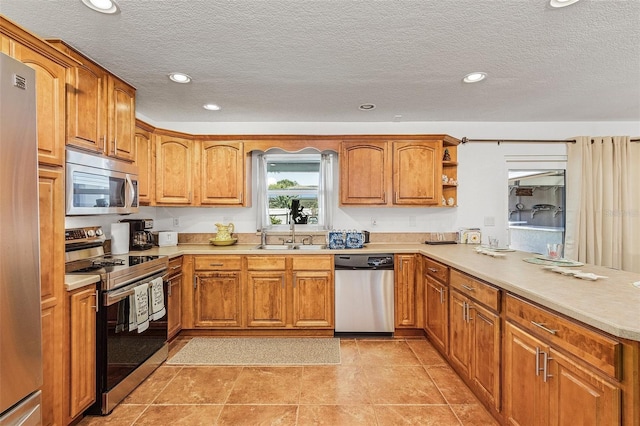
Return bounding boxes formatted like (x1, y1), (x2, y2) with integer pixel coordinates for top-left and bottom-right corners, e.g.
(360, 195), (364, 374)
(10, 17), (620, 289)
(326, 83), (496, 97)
(373, 405), (460, 426)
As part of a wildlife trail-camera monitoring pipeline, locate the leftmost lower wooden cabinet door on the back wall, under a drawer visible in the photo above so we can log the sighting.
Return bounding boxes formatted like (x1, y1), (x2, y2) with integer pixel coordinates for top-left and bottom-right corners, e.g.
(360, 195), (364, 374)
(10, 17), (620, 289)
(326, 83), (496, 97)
(194, 271), (242, 327)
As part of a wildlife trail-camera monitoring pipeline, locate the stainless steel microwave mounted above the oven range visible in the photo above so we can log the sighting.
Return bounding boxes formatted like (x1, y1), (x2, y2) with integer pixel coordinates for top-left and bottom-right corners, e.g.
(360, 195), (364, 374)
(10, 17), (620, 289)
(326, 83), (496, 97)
(65, 148), (138, 216)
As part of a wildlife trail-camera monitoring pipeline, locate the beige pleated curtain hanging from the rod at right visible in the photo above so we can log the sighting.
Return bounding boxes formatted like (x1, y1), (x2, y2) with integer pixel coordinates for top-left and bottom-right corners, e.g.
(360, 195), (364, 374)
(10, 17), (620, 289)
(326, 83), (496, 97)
(565, 136), (640, 272)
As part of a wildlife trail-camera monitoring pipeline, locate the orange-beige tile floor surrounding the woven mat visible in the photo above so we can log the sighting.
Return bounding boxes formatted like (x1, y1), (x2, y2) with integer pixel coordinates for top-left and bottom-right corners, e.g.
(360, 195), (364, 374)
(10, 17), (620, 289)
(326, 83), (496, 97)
(79, 338), (497, 426)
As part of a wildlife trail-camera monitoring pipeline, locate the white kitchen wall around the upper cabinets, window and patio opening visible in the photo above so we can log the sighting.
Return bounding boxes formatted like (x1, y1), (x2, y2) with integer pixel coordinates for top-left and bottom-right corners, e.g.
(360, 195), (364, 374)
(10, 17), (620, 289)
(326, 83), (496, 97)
(65, 120), (640, 242)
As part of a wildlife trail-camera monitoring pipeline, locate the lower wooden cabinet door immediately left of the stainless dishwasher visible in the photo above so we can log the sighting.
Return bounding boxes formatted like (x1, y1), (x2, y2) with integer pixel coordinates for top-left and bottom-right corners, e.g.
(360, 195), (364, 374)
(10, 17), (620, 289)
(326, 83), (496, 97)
(293, 271), (334, 328)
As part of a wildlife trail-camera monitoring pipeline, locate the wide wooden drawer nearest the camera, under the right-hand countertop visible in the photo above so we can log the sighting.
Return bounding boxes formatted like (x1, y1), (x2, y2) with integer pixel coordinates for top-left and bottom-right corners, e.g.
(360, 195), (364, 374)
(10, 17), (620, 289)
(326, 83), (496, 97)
(506, 294), (622, 379)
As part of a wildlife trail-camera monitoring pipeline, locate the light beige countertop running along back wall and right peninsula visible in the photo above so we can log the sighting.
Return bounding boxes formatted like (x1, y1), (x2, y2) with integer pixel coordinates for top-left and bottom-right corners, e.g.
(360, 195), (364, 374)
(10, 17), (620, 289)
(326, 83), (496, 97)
(65, 243), (640, 341)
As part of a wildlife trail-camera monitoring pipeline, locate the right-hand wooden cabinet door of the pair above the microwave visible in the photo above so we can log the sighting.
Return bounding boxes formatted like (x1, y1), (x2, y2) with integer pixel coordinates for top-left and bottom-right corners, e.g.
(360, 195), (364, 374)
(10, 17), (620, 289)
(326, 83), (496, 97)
(107, 75), (136, 161)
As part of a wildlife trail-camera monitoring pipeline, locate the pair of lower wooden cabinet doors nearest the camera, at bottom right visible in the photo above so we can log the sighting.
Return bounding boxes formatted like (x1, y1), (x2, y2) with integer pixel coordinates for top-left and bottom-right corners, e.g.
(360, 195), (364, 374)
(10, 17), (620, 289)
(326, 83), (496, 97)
(504, 322), (621, 426)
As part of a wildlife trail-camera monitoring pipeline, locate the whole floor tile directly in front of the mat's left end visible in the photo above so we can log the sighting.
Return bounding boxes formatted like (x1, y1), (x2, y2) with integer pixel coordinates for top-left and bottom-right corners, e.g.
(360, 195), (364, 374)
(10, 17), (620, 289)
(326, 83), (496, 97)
(154, 367), (242, 404)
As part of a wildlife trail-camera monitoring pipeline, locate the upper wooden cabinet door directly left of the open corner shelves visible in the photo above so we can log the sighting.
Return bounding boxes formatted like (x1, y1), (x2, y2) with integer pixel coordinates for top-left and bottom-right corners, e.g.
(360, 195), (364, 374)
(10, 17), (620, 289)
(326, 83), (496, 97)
(392, 141), (442, 206)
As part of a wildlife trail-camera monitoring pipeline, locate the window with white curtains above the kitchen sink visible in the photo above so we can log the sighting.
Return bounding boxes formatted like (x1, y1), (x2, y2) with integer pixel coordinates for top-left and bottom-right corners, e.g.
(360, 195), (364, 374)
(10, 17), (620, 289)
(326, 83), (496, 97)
(258, 151), (334, 229)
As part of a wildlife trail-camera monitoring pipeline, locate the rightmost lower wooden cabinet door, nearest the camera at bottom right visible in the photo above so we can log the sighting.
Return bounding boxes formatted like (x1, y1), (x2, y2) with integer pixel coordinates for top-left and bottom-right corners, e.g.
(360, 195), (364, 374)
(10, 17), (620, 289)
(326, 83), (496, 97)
(548, 349), (620, 426)
